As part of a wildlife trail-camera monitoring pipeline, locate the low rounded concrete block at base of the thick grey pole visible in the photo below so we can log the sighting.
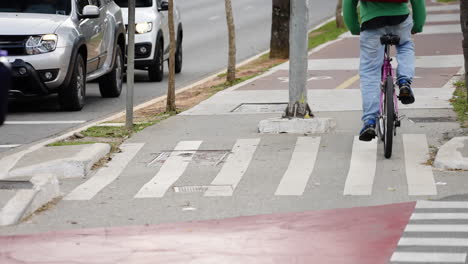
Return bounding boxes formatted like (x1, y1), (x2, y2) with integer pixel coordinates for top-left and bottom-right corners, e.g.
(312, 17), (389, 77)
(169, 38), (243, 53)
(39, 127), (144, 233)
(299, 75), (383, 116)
(258, 118), (336, 134)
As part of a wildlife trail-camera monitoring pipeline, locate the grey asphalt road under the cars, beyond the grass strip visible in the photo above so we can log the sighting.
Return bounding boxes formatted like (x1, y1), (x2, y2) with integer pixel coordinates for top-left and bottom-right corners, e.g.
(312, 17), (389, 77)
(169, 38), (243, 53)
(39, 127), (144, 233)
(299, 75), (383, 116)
(0, 0), (335, 152)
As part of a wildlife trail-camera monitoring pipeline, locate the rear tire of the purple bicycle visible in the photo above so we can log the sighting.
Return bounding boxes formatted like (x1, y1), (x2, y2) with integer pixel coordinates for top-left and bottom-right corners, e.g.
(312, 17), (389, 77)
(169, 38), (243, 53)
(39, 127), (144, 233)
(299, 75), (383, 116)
(383, 76), (395, 159)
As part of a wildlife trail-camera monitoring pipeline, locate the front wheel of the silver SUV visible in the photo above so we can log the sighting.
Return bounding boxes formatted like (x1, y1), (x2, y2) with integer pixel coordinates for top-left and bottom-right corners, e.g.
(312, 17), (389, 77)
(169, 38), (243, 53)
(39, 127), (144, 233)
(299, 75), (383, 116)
(59, 54), (86, 111)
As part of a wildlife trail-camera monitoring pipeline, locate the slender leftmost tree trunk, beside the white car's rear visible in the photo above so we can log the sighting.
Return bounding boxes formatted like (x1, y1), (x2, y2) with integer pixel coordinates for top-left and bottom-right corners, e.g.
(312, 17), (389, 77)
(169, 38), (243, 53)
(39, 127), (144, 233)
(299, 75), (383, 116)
(166, 0), (176, 112)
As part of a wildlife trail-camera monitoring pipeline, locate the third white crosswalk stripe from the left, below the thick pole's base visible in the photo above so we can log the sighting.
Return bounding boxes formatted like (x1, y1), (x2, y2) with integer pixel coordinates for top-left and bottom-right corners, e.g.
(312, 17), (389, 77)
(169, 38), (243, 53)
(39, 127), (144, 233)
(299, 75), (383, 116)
(204, 138), (260, 196)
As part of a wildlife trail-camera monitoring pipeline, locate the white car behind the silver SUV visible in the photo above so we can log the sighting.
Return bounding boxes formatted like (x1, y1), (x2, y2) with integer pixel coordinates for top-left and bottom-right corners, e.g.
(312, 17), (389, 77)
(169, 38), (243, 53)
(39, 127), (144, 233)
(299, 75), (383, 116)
(115, 0), (184, 82)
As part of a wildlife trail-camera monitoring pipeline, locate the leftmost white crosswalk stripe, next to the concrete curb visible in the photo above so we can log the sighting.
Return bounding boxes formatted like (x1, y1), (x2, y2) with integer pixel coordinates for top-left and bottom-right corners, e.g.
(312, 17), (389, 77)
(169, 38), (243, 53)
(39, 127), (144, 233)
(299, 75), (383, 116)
(64, 143), (144, 201)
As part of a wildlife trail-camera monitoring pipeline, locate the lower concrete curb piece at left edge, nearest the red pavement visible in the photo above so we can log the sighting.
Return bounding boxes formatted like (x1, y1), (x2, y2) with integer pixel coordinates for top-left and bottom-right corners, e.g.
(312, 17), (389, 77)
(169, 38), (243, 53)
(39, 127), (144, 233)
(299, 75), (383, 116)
(0, 174), (61, 226)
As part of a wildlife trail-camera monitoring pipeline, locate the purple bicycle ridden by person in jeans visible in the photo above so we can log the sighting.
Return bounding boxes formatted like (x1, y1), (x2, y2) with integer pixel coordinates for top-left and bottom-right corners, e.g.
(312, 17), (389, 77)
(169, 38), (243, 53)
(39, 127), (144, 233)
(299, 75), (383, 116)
(377, 34), (401, 159)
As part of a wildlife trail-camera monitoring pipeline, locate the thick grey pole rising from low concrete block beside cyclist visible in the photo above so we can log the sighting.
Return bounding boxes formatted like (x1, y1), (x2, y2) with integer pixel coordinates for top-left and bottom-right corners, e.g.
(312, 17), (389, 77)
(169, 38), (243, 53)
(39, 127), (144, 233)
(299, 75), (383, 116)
(285, 0), (313, 118)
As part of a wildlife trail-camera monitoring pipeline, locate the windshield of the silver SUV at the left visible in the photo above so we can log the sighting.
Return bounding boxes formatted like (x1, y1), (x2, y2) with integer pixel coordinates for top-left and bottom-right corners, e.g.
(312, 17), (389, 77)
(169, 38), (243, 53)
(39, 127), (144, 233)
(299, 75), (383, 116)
(0, 0), (71, 15)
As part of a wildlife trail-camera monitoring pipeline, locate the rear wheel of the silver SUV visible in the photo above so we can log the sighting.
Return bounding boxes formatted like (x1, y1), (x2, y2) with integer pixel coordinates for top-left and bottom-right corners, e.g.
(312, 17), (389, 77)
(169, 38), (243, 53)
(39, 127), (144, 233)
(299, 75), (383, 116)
(99, 46), (124, 98)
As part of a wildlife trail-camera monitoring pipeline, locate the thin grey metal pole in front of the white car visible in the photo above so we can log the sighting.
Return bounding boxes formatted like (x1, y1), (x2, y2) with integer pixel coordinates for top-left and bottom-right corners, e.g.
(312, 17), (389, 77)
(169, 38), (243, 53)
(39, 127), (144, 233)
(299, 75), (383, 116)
(125, 0), (135, 130)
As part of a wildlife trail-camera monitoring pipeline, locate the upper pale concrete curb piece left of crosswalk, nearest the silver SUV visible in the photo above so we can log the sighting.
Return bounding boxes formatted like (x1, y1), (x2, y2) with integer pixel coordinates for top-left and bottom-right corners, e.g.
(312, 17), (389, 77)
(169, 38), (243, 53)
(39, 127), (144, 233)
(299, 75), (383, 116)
(8, 143), (111, 179)
